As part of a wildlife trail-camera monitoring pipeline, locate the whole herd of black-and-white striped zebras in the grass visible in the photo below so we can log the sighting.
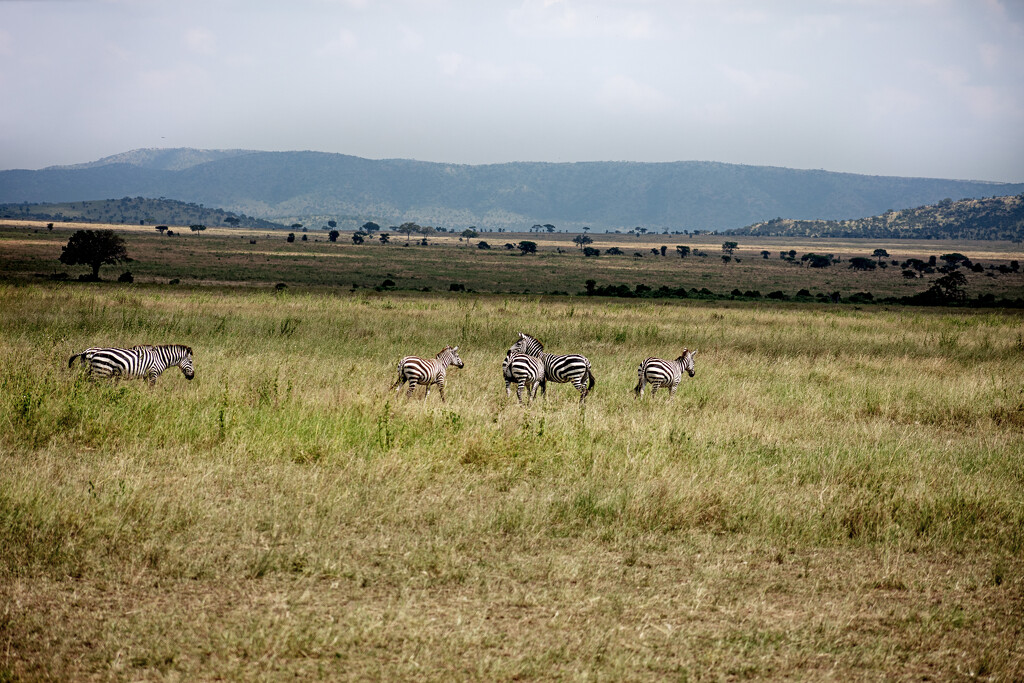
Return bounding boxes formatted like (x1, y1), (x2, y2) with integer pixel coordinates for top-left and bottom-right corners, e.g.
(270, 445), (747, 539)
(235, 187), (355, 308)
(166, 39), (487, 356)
(68, 332), (697, 403)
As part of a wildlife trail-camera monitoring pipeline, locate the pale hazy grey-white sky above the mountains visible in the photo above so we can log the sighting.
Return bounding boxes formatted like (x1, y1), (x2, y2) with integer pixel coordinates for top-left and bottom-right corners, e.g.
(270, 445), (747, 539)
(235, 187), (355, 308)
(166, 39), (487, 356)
(0, 0), (1024, 182)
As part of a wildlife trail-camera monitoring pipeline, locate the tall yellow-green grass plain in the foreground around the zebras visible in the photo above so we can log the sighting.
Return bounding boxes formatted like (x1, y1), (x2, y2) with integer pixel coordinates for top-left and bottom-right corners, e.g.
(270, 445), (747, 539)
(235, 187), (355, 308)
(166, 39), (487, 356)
(0, 222), (1024, 681)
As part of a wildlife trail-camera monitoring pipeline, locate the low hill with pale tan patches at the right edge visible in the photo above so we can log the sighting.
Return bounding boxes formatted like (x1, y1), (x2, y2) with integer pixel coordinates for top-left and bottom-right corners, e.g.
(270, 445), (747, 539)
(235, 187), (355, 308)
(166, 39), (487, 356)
(733, 195), (1024, 242)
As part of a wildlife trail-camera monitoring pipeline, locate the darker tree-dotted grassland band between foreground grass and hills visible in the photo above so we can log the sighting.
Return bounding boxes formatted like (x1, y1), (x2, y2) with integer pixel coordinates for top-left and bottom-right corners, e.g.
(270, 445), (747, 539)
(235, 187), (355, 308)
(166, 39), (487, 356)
(6, 221), (1024, 299)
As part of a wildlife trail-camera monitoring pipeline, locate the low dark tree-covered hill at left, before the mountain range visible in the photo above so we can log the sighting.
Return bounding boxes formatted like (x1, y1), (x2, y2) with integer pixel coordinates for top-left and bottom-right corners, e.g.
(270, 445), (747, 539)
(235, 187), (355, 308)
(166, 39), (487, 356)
(0, 197), (285, 230)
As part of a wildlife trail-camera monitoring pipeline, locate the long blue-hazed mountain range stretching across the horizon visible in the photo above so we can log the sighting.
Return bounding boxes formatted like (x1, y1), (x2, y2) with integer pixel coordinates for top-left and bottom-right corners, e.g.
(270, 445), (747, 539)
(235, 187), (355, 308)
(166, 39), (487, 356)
(0, 148), (1024, 231)
